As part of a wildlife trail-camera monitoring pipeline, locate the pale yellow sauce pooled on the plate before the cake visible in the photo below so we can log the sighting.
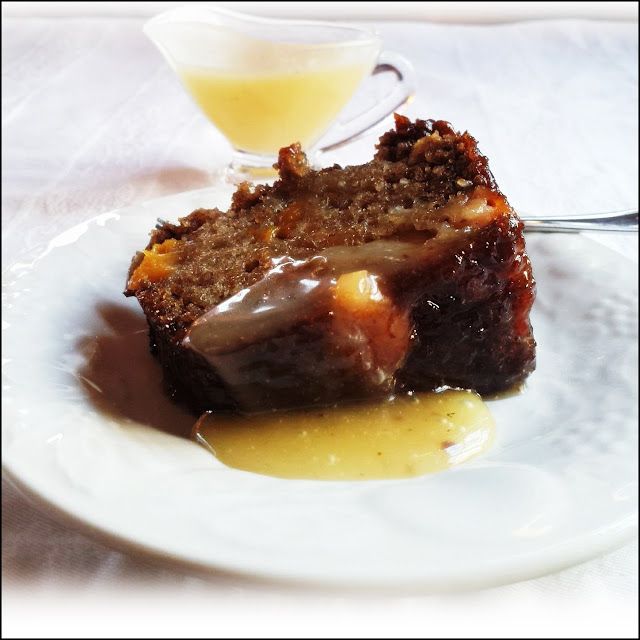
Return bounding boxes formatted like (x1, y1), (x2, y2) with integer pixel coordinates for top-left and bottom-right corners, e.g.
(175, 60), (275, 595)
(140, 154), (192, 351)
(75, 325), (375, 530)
(193, 389), (494, 480)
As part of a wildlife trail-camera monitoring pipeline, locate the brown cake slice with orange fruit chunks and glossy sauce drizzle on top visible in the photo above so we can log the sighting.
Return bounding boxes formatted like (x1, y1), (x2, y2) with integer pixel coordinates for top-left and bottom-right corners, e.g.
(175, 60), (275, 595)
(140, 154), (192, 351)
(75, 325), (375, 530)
(125, 116), (535, 412)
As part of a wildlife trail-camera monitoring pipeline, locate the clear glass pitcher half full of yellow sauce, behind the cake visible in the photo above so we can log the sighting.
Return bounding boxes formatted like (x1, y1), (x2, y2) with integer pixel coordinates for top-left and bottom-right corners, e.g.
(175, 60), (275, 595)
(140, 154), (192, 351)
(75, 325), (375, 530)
(144, 7), (413, 178)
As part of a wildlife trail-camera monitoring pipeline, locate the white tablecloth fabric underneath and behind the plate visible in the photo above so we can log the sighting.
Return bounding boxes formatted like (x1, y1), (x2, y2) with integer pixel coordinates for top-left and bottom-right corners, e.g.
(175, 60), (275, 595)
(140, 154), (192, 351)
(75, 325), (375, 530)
(2, 10), (638, 637)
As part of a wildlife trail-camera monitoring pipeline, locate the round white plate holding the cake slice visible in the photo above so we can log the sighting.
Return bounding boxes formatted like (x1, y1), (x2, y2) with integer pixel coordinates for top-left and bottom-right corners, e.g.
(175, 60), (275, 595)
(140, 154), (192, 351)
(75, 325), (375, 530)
(2, 189), (638, 589)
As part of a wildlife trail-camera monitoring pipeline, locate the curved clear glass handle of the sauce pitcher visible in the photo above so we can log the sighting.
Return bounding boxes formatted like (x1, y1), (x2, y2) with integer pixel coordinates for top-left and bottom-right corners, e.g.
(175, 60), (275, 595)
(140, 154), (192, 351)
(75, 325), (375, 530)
(317, 51), (415, 153)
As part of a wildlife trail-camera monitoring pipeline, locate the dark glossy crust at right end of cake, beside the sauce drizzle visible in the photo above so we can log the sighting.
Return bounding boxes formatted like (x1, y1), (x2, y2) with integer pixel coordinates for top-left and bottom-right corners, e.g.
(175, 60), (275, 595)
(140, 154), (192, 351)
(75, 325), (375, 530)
(397, 217), (535, 394)
